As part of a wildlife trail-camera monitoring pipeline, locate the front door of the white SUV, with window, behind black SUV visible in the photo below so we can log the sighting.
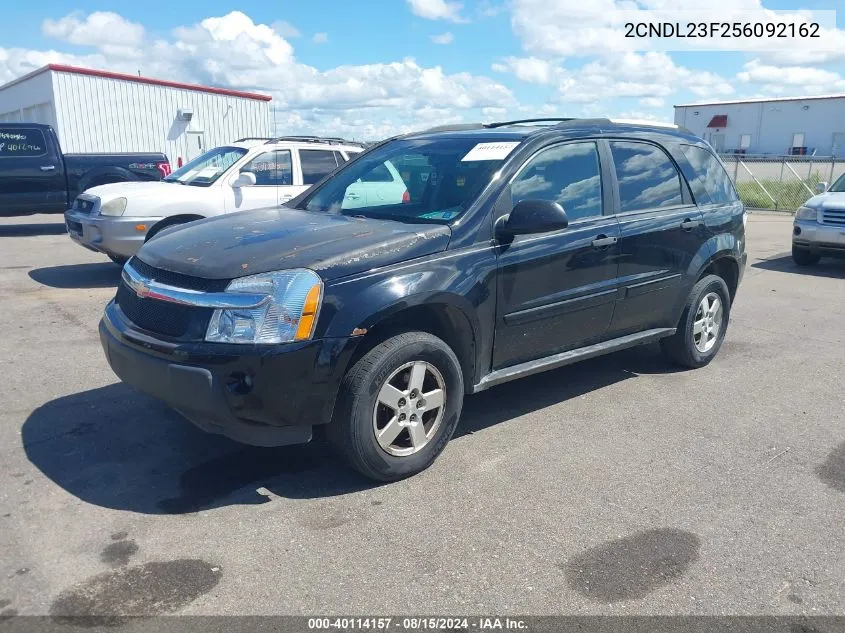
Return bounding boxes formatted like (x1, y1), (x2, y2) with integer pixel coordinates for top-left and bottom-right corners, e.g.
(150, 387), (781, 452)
(224, 149), (296, 213)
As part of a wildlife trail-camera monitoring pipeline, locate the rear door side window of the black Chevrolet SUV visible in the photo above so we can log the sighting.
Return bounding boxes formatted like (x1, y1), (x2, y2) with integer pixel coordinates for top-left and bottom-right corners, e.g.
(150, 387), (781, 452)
(610, 141), (683, 212)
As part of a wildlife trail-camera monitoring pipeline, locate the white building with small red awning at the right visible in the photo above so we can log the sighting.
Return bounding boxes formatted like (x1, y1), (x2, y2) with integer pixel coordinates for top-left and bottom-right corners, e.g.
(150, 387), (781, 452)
(675, 95), (845, 156)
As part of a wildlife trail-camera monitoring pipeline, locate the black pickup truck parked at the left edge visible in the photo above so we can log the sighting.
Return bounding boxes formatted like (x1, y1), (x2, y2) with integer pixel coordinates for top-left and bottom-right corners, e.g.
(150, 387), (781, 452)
(0, 123), (170, 216)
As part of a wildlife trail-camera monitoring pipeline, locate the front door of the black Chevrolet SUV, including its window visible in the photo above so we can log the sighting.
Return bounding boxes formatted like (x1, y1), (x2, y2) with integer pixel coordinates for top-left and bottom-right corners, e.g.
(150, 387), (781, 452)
(493, 141), (619, 369)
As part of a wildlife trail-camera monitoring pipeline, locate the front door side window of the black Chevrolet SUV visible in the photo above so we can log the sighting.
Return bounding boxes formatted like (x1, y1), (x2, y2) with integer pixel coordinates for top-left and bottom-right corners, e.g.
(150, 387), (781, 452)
(511, 143), (602, 222)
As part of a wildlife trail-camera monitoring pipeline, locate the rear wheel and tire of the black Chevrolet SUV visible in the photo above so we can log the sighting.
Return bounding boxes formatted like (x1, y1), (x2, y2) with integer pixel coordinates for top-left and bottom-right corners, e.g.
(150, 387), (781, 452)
(660, 275), (731, 369)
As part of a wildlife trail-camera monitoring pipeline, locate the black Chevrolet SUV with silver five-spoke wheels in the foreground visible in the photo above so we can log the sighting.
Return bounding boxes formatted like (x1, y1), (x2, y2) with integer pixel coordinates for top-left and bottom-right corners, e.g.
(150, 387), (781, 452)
(100, 119), (746, 481)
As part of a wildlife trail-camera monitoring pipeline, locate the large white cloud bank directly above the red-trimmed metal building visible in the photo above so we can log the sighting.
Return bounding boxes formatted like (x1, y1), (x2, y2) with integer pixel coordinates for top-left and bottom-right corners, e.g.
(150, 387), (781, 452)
(0, 11), (518, 139)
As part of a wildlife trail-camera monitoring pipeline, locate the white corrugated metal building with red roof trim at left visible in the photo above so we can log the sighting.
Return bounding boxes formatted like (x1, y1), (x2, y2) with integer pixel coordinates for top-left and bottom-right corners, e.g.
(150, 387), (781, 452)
(0, 64), (271, 168)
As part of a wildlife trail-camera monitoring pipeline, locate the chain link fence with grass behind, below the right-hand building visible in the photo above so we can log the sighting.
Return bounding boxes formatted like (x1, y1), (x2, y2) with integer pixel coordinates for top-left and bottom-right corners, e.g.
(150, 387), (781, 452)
(721, 154), (845, 212)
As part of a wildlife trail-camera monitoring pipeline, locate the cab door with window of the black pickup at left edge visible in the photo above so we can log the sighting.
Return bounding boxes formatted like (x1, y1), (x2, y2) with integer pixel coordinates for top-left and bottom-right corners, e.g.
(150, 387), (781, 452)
(0, 125), (67, 214)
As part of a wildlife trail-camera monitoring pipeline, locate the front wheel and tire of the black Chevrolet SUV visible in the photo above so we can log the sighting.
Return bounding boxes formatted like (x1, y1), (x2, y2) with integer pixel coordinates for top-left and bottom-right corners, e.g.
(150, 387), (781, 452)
(326, 332), (464, 481)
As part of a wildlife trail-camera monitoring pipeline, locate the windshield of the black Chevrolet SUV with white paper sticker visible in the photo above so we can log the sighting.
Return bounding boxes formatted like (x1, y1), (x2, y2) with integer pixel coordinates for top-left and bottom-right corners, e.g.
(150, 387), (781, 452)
(299, 138), (519, 224)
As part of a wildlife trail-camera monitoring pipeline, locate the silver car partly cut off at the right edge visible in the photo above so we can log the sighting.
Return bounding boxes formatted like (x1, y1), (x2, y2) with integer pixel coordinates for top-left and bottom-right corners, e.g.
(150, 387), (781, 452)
(792, 174), (845, 266)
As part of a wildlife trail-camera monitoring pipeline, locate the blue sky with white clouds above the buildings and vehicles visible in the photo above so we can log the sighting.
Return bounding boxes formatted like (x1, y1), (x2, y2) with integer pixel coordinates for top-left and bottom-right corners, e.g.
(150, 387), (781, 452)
(0, 0), (845, 138)
